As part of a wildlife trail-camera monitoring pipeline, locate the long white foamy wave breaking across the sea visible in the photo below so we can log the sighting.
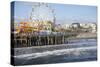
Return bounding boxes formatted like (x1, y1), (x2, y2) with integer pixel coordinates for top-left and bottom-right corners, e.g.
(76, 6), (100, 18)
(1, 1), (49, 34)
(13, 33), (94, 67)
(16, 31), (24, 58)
(14, 46), (97, 59)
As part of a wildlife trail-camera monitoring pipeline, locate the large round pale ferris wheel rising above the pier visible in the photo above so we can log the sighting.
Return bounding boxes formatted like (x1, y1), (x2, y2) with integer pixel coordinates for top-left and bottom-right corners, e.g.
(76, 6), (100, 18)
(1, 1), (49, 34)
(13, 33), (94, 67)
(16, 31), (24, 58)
(30, 3), (56, 24)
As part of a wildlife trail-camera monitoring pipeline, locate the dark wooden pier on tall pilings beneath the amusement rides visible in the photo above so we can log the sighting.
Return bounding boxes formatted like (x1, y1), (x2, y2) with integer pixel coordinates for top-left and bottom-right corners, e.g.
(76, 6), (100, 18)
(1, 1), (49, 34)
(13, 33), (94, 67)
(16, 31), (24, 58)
(12, 33), (77, 47)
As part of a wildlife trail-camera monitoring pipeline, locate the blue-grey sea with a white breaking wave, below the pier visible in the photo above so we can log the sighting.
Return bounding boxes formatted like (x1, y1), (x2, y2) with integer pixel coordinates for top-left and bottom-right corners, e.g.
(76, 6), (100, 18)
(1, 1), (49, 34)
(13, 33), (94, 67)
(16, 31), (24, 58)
(14, 39), (97, 65)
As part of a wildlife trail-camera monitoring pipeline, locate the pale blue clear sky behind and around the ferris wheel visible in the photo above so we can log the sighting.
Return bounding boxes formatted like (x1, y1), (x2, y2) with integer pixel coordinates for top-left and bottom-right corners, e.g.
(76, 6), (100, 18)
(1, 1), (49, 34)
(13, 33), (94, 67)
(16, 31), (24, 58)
(14, 1), (97, 24)
